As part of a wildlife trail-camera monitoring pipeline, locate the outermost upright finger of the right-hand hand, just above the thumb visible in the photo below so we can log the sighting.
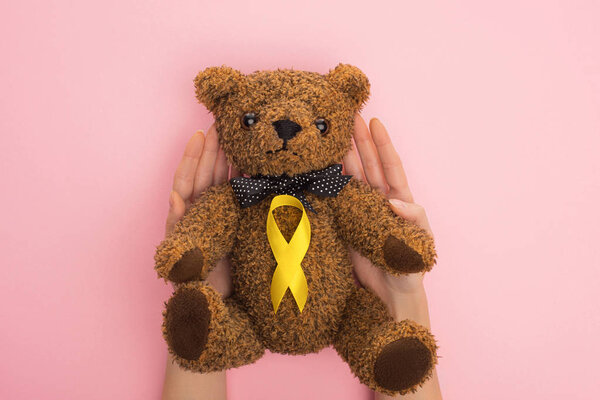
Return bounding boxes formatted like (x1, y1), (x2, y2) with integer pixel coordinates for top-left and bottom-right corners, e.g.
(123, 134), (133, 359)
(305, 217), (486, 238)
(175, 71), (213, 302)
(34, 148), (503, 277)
(369, 118), (414, 203)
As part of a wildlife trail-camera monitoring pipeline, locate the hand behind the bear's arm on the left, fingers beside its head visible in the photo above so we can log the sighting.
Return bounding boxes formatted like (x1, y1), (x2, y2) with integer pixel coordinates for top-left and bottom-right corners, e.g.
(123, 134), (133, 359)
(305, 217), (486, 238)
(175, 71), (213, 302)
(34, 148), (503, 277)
(165, 124), (239, 298)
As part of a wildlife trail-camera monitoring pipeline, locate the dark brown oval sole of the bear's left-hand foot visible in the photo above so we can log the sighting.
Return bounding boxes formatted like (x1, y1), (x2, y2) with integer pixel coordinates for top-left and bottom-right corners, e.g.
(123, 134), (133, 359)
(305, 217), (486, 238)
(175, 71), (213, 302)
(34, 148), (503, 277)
(165, 288), (211, 361)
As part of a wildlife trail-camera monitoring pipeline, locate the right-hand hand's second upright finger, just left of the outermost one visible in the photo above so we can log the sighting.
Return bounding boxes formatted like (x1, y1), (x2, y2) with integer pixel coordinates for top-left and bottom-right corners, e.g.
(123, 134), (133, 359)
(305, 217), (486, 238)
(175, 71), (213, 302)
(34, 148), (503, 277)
(354, 115), (388, 193)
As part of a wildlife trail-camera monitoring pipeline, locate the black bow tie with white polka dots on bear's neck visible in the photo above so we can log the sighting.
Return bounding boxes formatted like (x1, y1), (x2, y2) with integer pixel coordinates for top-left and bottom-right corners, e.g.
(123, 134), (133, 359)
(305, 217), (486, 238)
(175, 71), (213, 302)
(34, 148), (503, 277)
(229, 164), (352, 212)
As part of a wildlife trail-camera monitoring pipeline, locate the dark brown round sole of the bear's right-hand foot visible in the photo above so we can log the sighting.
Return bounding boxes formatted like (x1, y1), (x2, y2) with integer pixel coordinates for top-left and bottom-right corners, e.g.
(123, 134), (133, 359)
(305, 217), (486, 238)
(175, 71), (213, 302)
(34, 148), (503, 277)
(374, 337), (433, 391)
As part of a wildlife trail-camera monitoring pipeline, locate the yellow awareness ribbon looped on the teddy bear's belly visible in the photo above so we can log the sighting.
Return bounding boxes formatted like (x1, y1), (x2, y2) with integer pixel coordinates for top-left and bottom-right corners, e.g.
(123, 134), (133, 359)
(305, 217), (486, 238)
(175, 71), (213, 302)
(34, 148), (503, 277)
(267, 195), (310, 314)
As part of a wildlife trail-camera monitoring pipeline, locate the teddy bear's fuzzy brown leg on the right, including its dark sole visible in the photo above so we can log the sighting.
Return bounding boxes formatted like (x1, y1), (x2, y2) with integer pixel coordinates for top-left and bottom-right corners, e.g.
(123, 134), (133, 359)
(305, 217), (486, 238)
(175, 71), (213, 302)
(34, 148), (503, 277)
(334, 288), (437, 395)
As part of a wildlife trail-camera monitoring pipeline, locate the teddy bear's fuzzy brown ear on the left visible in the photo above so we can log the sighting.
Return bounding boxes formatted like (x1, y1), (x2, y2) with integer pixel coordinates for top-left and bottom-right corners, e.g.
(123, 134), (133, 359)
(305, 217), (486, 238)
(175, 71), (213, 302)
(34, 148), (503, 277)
(194, 65), (245, 112)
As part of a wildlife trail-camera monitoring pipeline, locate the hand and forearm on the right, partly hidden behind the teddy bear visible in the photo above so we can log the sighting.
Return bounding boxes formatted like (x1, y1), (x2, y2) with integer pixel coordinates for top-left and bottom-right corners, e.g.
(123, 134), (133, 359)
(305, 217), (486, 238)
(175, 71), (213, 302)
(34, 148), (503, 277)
(344, 115), (442, 400)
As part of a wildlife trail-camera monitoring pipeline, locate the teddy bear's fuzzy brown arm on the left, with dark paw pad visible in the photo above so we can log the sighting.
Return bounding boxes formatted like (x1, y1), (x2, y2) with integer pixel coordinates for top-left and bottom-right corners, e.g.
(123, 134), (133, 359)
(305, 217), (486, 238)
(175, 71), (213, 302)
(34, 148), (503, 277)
(154, 183), (239, 283)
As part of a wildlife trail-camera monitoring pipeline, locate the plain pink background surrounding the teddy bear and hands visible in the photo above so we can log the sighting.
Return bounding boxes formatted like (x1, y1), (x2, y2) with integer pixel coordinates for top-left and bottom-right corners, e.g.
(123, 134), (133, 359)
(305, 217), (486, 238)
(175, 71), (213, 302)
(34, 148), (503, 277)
(0, 0), (600, 400)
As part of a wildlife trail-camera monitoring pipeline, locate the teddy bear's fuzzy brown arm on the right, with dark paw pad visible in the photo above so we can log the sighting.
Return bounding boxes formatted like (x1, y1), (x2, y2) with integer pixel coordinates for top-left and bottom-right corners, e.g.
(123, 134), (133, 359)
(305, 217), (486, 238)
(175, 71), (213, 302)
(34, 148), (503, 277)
(332, 178), (436, 275)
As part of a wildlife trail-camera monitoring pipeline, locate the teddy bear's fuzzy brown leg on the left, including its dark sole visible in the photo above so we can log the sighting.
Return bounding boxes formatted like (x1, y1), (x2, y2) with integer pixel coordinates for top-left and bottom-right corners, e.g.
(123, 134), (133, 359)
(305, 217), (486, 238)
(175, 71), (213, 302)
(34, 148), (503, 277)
(163, 282), (265, 373)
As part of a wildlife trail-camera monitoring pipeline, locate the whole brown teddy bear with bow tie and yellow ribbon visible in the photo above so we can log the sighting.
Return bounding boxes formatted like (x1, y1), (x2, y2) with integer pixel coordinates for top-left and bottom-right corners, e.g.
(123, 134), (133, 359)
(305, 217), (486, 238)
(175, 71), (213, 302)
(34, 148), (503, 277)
(155, 64), (437, 395)
